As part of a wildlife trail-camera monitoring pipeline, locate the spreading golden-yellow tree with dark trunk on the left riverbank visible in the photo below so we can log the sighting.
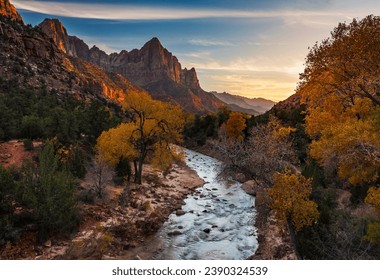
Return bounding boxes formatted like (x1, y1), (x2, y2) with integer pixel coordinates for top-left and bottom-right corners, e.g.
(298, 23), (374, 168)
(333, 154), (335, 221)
(97, 92), (184, 184)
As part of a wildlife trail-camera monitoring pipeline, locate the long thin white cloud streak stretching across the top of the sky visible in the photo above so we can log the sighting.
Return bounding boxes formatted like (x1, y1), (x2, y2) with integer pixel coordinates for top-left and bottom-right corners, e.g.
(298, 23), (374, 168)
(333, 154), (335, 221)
(12, 0), (345, 20)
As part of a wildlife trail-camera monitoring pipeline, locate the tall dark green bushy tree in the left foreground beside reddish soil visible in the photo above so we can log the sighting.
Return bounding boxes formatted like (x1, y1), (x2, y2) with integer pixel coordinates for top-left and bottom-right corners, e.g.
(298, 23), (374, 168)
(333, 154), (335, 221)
(22, 143), (78, 241)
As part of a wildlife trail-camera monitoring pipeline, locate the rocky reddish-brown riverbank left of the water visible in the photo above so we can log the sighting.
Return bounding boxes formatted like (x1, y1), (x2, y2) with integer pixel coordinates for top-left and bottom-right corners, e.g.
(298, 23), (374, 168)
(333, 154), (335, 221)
(0, 159), (204, 260)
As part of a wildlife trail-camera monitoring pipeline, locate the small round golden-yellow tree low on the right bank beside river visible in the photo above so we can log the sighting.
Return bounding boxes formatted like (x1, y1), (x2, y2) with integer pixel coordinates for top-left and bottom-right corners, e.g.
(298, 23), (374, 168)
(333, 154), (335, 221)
(268, 171), (319, 231)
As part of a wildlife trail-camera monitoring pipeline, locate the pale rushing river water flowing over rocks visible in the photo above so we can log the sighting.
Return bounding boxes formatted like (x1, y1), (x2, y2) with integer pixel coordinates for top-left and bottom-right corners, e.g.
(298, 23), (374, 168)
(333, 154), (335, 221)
(156, 150), (257, 260)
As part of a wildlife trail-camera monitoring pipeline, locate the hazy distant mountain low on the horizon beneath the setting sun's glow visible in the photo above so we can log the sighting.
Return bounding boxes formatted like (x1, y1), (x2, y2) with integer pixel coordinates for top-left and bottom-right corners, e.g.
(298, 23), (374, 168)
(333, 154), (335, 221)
(212, 92), (276, 115)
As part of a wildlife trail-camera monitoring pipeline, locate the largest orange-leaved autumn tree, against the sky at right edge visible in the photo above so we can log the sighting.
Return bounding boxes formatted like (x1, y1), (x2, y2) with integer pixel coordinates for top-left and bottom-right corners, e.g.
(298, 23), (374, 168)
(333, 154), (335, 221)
(298, 16), (380, 185)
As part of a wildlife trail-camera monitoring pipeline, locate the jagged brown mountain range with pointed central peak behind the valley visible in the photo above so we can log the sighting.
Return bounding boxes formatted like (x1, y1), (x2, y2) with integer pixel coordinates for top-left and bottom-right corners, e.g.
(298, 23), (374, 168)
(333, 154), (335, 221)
(39, 19), (225, 113)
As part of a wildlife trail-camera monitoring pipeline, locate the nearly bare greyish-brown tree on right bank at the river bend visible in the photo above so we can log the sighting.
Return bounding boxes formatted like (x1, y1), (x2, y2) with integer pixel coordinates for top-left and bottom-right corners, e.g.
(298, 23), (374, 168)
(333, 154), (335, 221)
(215, 116), (295, 184)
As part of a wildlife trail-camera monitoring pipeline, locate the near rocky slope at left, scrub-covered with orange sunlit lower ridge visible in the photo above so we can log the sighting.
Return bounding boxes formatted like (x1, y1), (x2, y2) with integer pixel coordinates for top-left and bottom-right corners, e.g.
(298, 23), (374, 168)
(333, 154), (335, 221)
(0, 0), (142, 105)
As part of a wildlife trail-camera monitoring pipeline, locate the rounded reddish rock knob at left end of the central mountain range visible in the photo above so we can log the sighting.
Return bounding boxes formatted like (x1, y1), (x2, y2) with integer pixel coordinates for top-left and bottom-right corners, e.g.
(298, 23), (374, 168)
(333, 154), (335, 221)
(39, 19), (72, 54)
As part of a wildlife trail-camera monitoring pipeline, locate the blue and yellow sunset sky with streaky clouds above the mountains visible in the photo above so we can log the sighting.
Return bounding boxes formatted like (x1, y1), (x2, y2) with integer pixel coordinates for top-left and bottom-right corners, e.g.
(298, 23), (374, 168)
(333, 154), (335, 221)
(11, 0), (380, 101)
